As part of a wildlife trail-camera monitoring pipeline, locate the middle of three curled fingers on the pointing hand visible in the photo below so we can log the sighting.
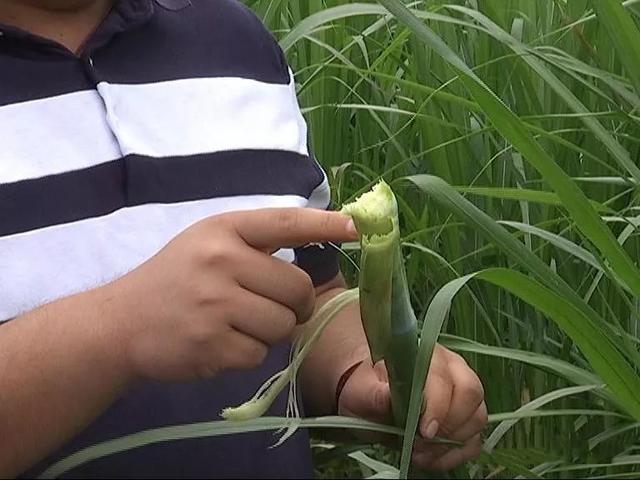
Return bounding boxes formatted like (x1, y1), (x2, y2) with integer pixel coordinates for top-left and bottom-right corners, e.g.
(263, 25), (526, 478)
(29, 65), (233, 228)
(229, 290), (296, 345)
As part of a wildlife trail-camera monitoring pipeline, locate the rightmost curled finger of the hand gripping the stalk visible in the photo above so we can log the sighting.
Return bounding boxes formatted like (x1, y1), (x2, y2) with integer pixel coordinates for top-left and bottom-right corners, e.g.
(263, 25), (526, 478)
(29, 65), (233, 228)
(441, 354), (484, 434)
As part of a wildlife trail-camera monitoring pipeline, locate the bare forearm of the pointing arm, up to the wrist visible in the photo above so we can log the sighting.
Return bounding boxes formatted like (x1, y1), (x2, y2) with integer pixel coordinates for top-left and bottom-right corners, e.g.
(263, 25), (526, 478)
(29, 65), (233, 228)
(0, 289), (130, 478)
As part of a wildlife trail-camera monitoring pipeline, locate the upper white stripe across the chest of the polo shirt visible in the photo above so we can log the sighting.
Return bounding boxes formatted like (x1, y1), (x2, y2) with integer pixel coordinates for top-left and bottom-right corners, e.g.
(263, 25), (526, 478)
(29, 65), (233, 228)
(0, 74), (308, 184)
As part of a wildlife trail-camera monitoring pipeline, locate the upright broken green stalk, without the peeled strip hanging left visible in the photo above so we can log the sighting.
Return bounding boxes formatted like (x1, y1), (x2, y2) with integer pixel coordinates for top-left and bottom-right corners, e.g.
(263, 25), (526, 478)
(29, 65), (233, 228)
(342, 181), (418, 427)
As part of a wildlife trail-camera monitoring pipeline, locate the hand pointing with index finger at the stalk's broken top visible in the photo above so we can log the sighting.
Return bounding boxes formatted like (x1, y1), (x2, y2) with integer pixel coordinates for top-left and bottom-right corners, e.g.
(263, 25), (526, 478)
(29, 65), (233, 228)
(104, 208), (356, 381)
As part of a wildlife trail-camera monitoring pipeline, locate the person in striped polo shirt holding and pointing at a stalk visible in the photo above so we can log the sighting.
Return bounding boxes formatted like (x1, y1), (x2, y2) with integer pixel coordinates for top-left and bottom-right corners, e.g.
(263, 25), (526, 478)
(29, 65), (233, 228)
(0, 0), (487, 478)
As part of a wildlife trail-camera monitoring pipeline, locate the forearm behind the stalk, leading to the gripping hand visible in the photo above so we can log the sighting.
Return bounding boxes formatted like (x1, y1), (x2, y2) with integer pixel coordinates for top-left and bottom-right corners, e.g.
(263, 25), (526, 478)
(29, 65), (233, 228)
(300, 281), (369, 415)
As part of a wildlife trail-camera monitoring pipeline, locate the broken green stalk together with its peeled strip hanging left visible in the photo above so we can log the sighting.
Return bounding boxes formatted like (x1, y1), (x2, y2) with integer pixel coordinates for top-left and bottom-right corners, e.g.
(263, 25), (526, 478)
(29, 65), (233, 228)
(222, 182), (418, 427)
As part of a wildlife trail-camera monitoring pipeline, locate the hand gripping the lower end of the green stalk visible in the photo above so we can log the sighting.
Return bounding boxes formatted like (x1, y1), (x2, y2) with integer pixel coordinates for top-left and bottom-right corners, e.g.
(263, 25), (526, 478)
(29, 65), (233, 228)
(338, 345), (487, 471)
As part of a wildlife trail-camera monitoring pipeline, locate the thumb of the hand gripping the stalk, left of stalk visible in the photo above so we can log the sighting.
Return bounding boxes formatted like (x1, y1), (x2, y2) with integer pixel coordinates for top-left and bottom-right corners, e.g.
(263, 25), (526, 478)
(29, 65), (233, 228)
(338, 362), (392, 423)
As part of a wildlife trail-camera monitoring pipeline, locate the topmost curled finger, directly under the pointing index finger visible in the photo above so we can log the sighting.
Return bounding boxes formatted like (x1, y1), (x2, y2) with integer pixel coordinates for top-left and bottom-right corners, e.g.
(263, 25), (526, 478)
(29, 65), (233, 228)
(234, 248), (316, 323)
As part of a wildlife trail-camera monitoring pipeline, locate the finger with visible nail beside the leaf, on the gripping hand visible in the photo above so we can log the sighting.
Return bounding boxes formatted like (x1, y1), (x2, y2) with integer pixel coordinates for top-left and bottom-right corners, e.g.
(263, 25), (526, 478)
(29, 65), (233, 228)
(420, 362), (453, 440)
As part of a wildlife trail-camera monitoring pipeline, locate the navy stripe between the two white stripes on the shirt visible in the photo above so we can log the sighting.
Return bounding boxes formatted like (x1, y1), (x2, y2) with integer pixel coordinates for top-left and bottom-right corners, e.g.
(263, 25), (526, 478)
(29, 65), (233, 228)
(0, 150), (326, 237)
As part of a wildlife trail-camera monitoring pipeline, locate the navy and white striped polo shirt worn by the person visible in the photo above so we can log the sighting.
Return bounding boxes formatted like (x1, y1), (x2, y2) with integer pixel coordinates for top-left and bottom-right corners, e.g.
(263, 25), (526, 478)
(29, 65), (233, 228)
(0, 0), (338, 478)
